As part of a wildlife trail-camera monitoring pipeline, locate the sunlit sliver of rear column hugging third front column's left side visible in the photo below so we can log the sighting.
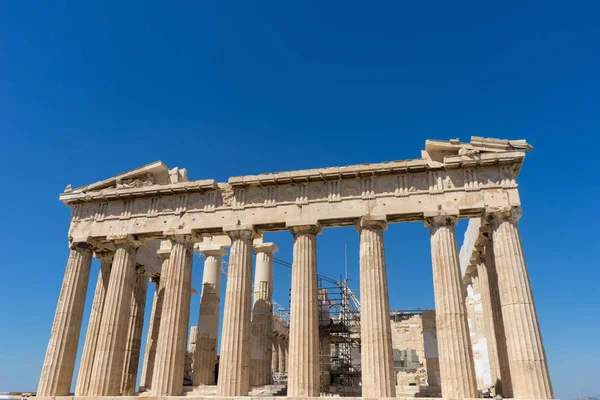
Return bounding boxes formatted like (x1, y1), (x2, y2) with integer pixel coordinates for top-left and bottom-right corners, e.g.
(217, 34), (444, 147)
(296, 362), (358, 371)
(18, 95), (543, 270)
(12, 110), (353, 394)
(140, 276), (163, 392)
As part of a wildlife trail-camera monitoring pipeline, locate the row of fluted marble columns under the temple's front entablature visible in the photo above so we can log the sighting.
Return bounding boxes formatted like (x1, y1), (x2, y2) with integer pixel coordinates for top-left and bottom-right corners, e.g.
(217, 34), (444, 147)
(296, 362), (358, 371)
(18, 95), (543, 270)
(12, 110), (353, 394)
(38, 210), (552, 399)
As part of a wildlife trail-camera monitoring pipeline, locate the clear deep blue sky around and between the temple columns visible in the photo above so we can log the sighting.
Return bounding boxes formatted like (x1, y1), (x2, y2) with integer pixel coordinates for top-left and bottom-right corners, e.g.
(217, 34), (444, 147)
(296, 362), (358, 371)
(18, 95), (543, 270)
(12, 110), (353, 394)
(0, 0), (600, 399)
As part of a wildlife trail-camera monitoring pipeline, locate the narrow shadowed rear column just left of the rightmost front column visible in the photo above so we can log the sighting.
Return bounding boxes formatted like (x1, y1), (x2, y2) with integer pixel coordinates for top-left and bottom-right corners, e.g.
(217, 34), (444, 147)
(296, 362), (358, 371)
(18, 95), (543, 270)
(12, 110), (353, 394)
(483, 241), (513, 398)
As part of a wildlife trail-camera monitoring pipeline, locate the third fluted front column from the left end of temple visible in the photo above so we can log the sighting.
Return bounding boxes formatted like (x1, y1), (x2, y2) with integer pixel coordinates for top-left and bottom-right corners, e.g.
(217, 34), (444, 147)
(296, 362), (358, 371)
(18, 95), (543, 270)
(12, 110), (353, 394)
(151, 236), (193, 396)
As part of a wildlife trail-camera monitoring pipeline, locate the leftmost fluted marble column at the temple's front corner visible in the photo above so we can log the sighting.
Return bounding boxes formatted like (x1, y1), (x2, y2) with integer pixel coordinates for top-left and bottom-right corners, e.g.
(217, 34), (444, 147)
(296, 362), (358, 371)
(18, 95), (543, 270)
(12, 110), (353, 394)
(37, 243), (92, 396)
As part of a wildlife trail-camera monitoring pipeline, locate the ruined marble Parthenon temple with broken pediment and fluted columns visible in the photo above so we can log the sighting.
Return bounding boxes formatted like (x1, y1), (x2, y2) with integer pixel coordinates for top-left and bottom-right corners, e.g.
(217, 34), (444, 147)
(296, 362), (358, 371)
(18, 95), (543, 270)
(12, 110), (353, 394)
(37, 137), (553, 399)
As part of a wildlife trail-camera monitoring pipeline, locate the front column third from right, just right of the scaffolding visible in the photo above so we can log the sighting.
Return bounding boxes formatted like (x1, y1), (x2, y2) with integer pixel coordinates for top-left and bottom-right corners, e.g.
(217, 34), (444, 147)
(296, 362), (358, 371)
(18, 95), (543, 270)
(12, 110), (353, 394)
(357, 216), (396, 397)
